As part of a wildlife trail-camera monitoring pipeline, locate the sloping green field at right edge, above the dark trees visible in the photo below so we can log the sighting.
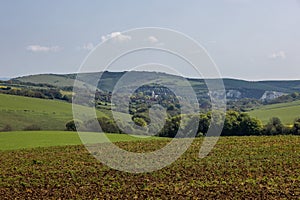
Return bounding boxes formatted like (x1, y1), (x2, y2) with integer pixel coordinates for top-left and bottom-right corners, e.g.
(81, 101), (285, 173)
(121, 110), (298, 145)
(248, 101), (300, 125)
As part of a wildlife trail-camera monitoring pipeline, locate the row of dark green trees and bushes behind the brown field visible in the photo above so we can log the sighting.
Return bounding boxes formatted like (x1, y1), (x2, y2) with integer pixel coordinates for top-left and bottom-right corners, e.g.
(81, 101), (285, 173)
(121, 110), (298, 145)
(66, 111), (300, 138)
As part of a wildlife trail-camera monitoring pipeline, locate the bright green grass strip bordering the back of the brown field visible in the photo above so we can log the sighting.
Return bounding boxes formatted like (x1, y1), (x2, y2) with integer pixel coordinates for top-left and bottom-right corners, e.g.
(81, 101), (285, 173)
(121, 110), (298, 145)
(0, 131), (163, 150)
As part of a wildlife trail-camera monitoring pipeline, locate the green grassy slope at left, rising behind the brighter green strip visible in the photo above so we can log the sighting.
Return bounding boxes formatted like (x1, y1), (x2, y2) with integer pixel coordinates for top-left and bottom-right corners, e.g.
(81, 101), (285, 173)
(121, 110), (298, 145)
(0, 94), (104, 130)
